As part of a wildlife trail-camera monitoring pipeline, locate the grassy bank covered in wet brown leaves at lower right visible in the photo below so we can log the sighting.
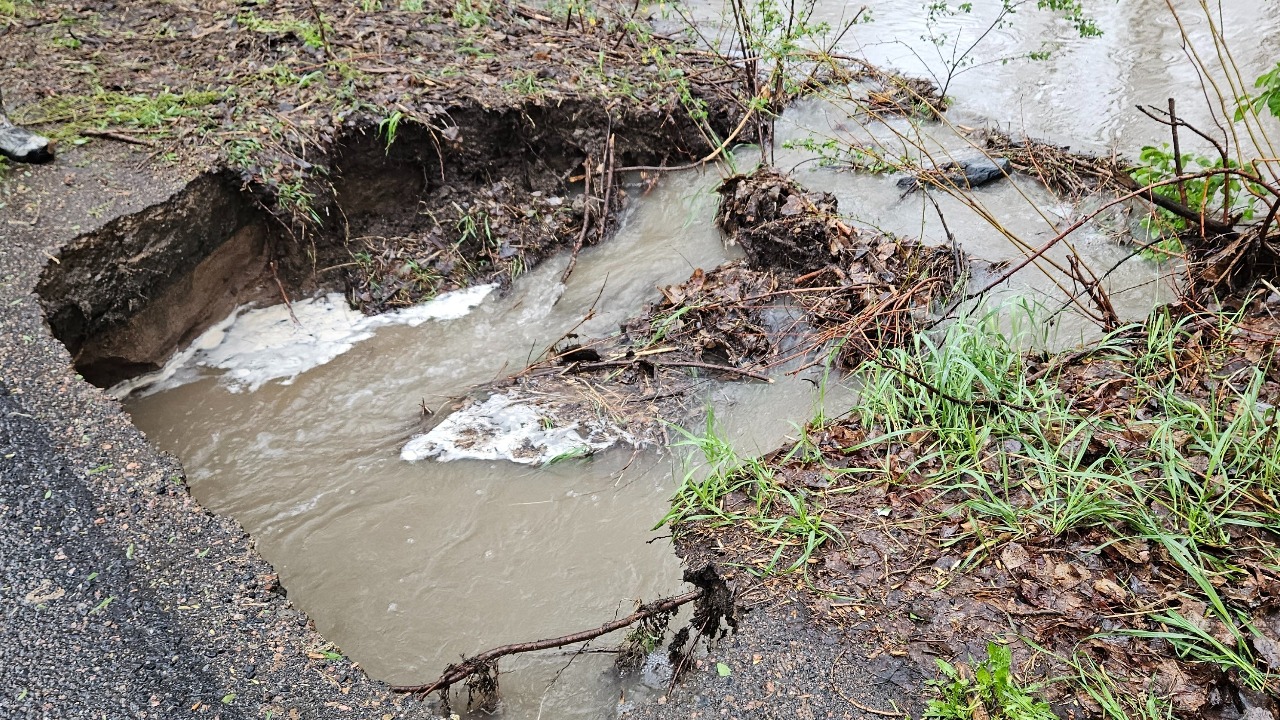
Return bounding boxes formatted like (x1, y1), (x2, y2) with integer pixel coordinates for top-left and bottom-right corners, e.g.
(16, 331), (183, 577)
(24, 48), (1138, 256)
(668, 297), (1280, 720)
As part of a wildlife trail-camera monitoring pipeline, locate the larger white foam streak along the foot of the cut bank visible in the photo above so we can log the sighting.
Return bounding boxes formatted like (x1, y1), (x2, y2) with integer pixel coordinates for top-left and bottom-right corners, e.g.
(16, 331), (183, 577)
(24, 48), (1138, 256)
(108, 284), (498, 397)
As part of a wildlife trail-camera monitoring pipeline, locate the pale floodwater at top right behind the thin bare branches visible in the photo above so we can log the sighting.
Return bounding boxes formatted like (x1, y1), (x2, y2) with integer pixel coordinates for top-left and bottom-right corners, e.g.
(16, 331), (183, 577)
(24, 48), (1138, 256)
(690, 0), (1280, 155)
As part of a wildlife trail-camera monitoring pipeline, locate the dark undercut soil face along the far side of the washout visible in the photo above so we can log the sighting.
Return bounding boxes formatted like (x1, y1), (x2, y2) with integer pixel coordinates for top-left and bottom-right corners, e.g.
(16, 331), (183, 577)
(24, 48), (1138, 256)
(37, 101), (737, 387)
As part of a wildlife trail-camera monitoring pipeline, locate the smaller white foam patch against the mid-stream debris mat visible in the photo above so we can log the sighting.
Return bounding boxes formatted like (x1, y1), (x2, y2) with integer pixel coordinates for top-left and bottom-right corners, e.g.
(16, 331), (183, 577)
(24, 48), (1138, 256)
(401, 395), (622, 465)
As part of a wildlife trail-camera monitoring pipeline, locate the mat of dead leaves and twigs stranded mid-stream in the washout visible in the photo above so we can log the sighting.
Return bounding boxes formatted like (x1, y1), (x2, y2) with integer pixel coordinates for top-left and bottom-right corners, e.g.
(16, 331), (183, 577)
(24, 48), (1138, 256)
(445, 169), (964, 460)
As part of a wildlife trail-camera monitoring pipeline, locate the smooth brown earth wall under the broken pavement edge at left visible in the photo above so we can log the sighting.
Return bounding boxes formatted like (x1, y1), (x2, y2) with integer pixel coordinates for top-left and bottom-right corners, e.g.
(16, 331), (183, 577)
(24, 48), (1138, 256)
(37, 173), (271, 386)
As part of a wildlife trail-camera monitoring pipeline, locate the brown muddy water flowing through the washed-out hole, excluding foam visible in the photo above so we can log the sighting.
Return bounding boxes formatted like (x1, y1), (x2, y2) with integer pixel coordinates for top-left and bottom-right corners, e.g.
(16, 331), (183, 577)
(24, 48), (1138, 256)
(128, 173), (844, 717)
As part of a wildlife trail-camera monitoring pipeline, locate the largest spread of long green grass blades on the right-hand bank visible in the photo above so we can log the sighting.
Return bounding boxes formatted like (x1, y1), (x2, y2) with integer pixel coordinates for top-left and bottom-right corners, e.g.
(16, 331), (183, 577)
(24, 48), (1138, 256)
(831, 302), (1280, 692)
